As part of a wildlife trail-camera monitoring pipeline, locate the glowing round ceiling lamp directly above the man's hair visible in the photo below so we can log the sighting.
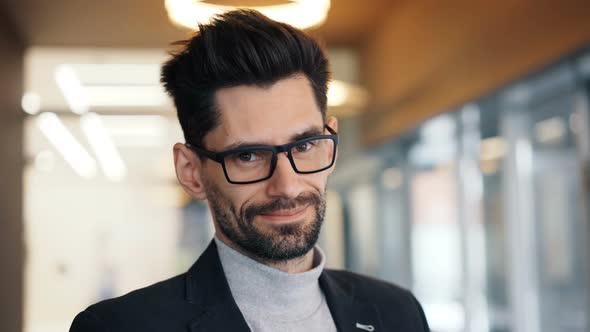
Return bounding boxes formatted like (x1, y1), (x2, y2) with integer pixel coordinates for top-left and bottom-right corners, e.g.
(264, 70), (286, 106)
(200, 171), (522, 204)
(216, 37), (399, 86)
(165, 0), (330, 30)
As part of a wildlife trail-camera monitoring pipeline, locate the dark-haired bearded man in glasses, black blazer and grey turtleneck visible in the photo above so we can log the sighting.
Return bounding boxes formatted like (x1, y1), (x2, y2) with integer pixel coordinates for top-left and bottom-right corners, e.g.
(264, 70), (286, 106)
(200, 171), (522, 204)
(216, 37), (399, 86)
(70, 10), (429, 332)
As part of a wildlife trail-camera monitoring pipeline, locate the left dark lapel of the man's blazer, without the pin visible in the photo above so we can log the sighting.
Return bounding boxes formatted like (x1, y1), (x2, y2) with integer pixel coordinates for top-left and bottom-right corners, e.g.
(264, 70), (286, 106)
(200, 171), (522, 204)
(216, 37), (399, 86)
(186, 241), (250, 332)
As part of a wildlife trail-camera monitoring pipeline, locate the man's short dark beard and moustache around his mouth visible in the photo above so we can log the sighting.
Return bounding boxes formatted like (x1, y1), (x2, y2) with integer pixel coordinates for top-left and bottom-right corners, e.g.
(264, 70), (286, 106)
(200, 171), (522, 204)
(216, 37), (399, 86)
(205, 183), (326, 261)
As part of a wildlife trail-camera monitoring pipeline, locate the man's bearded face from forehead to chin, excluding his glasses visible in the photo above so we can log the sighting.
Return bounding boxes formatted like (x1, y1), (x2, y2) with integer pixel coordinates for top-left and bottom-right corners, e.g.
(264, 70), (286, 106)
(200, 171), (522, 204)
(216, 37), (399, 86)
(201, 75), (337, 261)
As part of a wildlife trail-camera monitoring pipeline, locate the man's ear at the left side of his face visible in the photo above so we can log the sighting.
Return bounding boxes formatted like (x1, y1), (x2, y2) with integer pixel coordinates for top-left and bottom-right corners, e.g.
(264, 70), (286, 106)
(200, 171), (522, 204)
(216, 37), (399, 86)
(174, 143), (207, 200)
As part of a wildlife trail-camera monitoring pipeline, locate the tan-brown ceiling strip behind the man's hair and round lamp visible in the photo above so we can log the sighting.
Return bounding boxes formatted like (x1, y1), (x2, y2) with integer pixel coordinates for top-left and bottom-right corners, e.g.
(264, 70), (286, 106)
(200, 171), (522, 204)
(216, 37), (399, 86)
(0, 0), (399, 48)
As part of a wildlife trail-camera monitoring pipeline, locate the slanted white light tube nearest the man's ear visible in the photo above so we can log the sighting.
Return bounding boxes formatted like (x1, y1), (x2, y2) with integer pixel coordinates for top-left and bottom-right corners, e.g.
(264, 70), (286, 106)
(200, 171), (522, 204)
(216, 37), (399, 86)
(80, 113), (127, 181)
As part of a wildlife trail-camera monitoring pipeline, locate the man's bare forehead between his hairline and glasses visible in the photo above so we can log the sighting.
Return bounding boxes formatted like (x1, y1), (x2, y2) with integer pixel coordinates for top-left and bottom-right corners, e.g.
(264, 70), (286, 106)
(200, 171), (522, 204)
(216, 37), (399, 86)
(207, 75), (323, 148)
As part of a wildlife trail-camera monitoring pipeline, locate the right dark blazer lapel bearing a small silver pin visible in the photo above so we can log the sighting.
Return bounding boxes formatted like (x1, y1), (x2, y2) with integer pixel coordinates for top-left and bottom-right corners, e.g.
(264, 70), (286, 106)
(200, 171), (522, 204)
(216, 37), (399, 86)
(320, 270), (384, 332)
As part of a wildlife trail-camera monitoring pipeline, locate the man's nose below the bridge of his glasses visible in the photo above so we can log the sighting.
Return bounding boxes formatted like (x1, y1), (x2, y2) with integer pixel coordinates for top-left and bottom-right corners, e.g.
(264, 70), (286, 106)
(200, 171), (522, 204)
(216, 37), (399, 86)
(267, 152), (303, 198)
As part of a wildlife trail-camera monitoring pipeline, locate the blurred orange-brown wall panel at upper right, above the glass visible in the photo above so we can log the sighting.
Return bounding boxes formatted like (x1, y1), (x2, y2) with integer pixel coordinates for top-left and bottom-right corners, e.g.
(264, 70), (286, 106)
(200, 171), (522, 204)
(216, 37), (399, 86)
(362, 0), (590, 144)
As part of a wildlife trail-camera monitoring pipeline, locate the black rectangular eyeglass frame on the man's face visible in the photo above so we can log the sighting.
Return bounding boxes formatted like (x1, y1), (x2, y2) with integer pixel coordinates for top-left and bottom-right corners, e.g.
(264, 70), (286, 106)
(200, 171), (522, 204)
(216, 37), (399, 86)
(184, 125), (338, 184)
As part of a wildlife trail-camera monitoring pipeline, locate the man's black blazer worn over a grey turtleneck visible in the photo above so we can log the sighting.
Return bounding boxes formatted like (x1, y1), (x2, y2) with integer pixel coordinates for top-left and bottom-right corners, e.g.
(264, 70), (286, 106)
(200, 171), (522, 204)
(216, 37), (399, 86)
(70, 241), (430, 332)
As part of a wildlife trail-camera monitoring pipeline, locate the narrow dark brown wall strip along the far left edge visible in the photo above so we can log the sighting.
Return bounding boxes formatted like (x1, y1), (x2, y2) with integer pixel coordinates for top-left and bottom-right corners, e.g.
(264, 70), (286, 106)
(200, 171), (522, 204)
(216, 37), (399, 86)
(0, 9), (24, 332)
